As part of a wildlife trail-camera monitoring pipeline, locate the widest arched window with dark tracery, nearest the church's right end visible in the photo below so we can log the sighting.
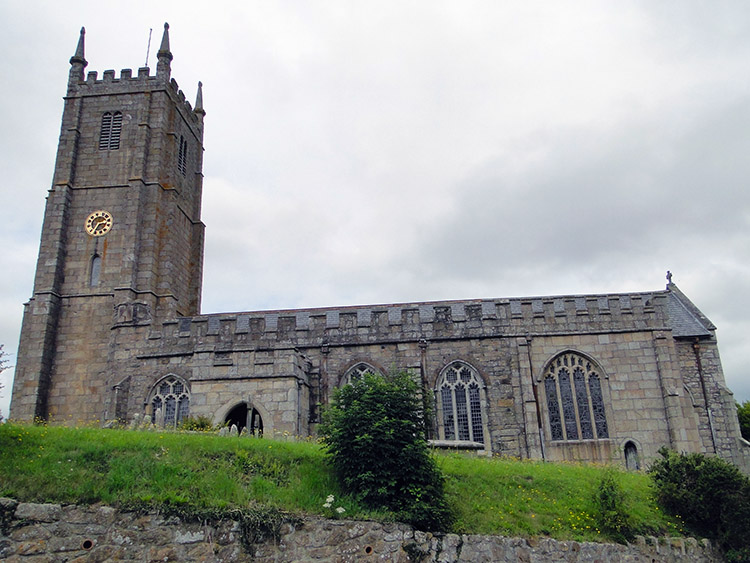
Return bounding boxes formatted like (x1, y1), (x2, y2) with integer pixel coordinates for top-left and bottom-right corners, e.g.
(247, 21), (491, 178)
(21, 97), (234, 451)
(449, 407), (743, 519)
(544, 352), (609, 441)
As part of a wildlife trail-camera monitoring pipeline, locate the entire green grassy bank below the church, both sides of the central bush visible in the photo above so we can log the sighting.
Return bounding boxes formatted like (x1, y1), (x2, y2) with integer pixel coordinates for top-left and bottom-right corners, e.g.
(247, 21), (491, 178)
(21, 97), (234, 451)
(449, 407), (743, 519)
(0, 424), (682, 541)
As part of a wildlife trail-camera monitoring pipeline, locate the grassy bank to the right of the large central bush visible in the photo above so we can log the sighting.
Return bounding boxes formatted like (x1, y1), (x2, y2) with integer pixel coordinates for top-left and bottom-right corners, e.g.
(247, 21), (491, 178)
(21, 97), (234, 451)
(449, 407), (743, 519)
(438, 454), (684, 541)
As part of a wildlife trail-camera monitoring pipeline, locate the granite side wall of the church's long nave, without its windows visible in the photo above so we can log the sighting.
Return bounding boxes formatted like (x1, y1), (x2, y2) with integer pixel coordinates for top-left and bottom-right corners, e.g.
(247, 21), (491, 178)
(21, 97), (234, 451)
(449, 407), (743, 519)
(101, 290), (750, 471)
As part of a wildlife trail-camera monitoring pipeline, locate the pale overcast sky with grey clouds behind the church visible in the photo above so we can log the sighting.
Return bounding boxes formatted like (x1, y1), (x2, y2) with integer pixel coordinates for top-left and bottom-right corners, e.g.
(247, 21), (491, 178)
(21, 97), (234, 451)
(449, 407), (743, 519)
(0, 0), (750, 415)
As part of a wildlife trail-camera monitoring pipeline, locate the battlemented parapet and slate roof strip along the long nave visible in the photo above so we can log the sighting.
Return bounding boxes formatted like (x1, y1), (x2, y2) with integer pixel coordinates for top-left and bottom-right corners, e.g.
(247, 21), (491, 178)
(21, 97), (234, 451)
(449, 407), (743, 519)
(137, 292), (670, 349)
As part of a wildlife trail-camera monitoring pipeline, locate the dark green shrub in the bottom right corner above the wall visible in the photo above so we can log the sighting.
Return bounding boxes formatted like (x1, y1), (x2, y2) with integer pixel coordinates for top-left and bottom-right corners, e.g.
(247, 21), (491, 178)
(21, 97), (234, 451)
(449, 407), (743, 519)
(649, 448), (750, 561)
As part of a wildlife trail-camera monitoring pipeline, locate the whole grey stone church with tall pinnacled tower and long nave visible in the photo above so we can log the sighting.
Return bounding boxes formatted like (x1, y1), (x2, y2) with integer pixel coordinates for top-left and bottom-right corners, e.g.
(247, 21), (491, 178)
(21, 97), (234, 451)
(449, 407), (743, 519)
(10, 25), (750, 471)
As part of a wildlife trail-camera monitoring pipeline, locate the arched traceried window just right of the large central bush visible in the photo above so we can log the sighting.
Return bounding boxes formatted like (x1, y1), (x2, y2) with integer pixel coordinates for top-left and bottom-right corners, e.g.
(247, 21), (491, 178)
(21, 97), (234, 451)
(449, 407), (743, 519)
(435, 362), (485, 442)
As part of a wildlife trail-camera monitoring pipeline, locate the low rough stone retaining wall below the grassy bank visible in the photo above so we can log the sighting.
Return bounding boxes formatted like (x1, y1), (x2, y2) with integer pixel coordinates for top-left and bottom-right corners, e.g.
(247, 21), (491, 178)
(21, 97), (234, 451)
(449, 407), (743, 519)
(0, 499), (723, 563)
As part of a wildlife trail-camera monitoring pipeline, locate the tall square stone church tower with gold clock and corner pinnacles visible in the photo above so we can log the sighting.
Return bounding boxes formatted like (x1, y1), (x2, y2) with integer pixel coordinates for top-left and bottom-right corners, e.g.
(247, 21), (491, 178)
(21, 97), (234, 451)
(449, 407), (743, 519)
(10, 24), (205, 422)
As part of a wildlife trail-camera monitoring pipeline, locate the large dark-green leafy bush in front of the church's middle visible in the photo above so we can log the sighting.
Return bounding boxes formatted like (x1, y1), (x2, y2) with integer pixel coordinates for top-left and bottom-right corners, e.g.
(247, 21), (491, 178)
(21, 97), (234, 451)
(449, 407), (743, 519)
(321, 373), (453, 531)
